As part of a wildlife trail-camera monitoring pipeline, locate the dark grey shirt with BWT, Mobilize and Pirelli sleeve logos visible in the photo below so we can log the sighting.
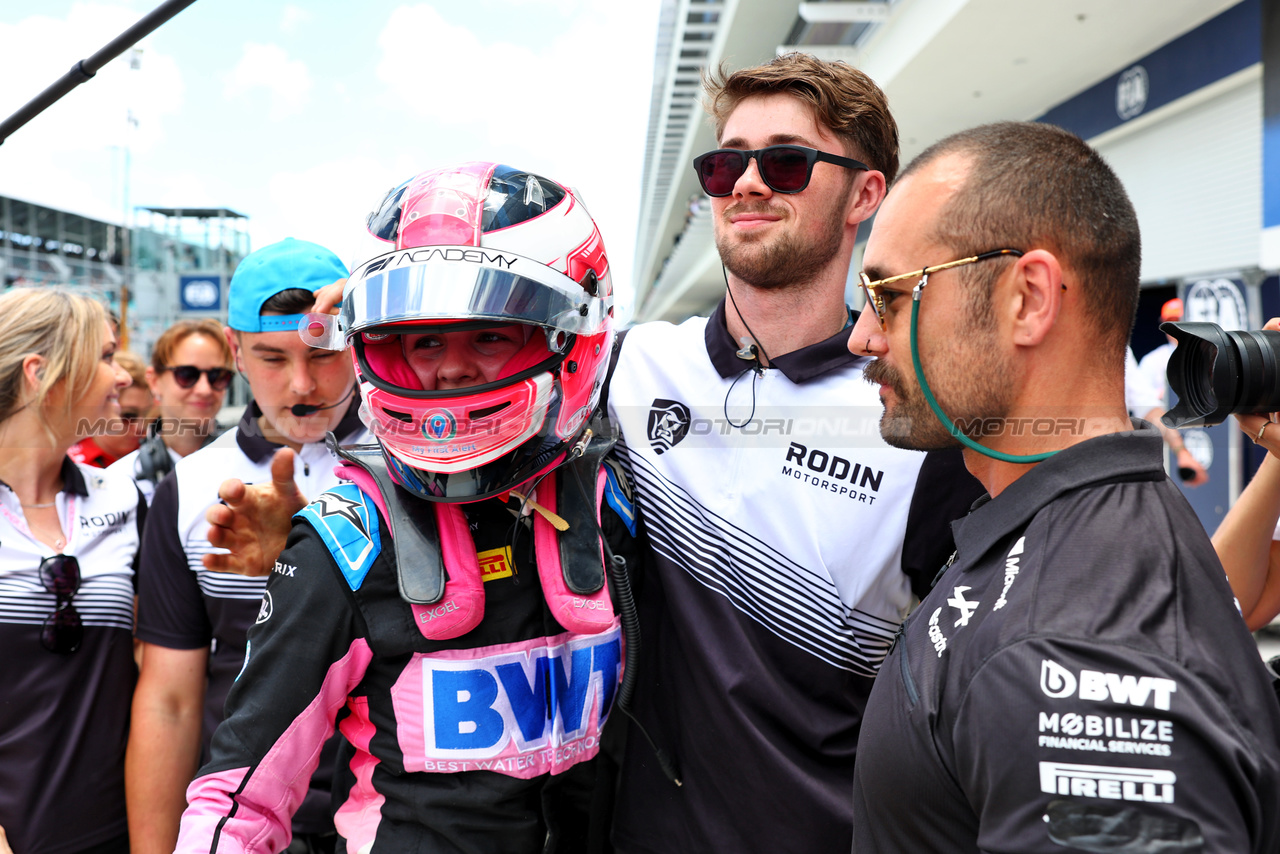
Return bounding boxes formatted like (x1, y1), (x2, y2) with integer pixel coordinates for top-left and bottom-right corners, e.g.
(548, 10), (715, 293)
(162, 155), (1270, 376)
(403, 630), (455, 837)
(854, 423), (1280, 854)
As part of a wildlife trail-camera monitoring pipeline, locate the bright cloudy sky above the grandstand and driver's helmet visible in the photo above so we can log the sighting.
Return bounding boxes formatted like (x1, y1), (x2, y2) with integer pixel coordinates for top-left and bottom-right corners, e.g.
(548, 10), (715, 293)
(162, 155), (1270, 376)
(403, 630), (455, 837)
(0, 0), (659, 316)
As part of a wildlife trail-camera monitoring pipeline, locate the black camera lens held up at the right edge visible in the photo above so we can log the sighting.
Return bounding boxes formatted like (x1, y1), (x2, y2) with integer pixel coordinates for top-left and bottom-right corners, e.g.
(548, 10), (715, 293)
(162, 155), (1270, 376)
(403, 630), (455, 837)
(1160, 323), (1280, 428)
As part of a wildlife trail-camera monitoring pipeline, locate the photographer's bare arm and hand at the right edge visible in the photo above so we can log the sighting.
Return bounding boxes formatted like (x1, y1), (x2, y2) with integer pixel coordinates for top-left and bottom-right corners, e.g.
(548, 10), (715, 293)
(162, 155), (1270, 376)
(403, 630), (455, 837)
(1213, 318), (1280, 631)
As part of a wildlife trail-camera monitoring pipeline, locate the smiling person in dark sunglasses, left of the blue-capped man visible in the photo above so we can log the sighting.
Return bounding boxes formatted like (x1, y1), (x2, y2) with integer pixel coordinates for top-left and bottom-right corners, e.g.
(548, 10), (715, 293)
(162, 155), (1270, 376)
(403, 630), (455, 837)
(106, 318), (234, 503)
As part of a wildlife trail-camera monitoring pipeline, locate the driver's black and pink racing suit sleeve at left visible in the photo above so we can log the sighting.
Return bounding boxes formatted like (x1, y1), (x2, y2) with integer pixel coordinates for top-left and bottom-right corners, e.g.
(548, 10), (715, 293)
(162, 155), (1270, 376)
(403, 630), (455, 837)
(177, 524), (372, 854)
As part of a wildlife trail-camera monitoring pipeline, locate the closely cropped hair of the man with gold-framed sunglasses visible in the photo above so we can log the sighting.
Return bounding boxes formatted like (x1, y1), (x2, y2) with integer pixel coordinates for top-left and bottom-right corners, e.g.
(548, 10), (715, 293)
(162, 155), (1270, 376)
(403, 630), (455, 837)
(902, 122), (1142, 359)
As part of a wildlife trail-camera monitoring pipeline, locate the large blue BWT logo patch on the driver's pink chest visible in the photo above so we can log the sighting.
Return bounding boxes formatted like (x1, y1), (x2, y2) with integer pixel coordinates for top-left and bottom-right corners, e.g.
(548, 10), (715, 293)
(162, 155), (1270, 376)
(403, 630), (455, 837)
(394, 621), (622, 778)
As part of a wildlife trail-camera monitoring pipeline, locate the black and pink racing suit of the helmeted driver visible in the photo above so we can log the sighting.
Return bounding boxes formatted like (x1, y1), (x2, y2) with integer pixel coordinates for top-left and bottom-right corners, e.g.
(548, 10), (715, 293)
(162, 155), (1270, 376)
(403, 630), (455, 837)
(178, 448), (635, 854)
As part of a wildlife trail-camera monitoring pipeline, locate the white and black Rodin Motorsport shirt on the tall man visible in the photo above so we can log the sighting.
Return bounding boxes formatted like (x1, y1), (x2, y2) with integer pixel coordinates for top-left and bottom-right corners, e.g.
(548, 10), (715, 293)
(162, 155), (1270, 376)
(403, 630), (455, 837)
(608, 302), (982, 854)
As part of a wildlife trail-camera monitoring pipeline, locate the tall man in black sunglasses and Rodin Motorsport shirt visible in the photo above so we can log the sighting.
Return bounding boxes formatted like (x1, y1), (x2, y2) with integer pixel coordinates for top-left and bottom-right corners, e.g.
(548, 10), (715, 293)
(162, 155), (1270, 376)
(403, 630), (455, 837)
(608, 54), (980, 854)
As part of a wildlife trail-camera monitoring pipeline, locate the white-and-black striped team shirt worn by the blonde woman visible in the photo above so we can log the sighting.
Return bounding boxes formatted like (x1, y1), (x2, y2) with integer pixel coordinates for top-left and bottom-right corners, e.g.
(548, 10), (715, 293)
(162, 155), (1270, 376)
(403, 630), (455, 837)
(0, 457), (146, 853)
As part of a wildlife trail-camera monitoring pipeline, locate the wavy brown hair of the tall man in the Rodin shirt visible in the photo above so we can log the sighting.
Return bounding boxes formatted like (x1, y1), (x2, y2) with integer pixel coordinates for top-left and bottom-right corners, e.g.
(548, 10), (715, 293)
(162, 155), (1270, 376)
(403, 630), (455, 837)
(703, 52), (897, 183)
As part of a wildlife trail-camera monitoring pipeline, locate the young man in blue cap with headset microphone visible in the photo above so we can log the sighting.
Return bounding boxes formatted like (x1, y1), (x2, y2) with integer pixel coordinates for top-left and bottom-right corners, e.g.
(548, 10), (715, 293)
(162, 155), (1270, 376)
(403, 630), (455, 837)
(125, 238), (370, 853)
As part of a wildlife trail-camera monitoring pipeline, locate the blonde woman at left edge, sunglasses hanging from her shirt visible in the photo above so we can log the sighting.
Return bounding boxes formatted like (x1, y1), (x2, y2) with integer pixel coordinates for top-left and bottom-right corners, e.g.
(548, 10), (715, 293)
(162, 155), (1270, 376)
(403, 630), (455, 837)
(0, 288), (145, 854)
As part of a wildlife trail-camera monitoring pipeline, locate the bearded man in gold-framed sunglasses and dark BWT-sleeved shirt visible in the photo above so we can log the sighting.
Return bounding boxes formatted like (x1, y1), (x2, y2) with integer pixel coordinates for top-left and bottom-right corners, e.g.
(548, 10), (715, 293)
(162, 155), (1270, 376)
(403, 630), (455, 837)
(849, 123), (1280, 854)
